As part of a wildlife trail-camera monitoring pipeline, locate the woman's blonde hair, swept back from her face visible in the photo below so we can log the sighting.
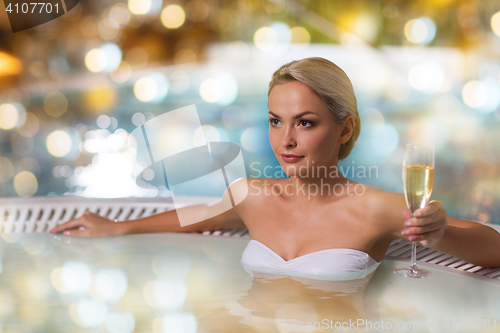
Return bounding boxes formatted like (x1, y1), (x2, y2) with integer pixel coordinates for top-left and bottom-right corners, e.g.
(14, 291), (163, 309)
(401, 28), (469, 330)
(267, 57), (361, 160)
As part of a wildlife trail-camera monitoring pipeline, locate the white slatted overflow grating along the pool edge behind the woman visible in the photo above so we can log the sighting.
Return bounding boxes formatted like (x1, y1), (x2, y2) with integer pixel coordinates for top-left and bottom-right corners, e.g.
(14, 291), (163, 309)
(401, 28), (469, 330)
(0, 196), (500, 283)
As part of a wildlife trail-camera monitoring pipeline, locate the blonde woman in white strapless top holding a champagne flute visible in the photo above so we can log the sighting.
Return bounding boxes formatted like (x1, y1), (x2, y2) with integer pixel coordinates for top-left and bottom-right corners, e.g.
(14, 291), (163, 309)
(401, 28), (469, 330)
(51, 58), (500, 280)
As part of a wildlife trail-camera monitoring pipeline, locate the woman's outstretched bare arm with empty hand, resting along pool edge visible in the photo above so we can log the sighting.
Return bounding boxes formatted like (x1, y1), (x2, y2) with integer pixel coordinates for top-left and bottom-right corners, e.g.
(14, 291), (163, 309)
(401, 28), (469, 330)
(50, 181), (245, 237)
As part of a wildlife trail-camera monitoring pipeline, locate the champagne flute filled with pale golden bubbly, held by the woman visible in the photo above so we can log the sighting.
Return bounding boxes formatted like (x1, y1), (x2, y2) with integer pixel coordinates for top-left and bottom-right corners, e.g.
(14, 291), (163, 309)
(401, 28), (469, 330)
(394, 144), (434, 278)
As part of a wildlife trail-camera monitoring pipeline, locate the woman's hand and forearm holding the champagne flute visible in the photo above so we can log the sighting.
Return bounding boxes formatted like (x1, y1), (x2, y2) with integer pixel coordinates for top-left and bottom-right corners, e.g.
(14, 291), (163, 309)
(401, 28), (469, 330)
(399, 201), (500, 267)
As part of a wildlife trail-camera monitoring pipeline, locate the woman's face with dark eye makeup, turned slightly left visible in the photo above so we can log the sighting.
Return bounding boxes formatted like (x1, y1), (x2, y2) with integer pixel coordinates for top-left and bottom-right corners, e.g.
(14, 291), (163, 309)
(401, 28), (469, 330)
(268, 81), (343, 177)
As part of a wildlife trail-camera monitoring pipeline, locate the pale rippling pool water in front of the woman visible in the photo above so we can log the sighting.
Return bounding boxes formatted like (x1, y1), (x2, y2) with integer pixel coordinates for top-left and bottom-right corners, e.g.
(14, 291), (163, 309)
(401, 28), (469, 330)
(0, 234), (500, 333)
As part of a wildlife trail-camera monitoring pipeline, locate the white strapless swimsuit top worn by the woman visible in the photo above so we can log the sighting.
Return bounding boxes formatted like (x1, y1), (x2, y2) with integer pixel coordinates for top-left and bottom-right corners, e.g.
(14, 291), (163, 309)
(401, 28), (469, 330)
(240, 239), (381, 281)
